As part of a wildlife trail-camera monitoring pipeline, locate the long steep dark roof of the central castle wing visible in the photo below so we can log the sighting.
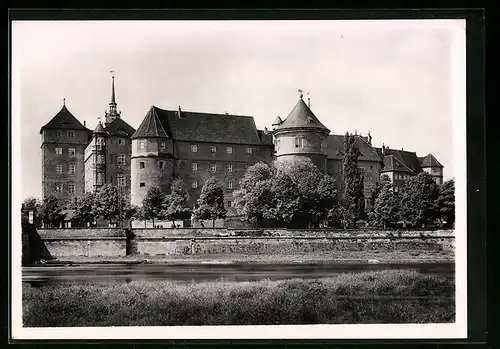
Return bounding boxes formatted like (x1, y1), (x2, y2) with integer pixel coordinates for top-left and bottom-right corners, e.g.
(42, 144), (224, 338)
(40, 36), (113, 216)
(132, 107), (261, 144)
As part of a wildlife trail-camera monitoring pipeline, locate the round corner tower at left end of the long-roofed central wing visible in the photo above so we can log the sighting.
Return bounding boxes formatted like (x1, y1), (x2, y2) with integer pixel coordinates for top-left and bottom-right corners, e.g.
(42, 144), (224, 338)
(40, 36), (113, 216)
(130, 106), (174, 206)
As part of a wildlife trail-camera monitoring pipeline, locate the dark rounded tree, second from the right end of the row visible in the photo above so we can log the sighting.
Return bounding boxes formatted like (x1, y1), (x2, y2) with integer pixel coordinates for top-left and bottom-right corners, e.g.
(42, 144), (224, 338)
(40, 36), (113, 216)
(401, 172), (439, 227)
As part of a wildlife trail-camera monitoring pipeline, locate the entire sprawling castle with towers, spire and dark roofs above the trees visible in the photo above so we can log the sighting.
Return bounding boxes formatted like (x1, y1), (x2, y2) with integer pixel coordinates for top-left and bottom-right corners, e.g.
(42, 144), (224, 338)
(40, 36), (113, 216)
(40, 81), (443, 222)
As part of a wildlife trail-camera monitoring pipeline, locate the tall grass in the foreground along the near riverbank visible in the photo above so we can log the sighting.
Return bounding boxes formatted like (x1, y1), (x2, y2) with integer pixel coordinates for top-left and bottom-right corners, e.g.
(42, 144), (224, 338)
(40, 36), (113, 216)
(23, 270), (455, 327)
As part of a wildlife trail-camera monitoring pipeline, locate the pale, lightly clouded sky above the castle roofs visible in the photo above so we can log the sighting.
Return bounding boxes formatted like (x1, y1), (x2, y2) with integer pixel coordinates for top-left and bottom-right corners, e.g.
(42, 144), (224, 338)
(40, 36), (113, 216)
(12, 20), (465, 198)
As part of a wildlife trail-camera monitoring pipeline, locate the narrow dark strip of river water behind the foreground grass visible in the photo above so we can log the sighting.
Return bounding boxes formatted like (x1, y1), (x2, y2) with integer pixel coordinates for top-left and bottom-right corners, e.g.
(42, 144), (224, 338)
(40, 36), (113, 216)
(23, 263), (455, 283)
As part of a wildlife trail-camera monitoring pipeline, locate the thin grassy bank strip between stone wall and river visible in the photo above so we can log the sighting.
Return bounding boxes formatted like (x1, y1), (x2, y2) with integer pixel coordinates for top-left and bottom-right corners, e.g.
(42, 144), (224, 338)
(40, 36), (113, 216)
(44, 251), (454, 264)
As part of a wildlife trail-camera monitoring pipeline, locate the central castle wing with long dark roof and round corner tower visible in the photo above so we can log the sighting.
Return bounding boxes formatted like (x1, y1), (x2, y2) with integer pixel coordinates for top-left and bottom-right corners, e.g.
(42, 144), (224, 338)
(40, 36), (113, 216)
(131, 106), (273, 215)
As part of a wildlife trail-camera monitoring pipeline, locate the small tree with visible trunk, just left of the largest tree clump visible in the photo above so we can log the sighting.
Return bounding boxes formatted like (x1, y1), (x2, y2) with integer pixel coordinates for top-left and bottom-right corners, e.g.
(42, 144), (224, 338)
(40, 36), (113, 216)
(194, 177), (227, 227)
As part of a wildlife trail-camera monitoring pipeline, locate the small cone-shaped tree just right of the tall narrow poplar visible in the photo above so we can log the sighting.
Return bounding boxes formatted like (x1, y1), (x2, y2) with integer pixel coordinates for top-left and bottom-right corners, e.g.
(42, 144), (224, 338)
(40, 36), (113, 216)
(369, 176), (400, 229)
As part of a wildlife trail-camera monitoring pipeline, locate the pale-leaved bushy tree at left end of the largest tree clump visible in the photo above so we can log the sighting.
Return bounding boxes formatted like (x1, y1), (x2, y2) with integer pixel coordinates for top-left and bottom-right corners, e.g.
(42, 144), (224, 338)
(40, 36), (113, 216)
(233, 162), (275, 226)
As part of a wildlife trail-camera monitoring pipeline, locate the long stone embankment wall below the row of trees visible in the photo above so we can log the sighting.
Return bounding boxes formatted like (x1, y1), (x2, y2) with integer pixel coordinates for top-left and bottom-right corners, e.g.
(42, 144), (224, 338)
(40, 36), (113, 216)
(27, 228), (455, 258)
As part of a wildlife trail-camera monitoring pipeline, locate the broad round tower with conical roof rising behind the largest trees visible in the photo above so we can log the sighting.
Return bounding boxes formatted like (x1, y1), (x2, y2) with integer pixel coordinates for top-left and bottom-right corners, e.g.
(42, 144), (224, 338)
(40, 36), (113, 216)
(273, 92), (330, 172)
